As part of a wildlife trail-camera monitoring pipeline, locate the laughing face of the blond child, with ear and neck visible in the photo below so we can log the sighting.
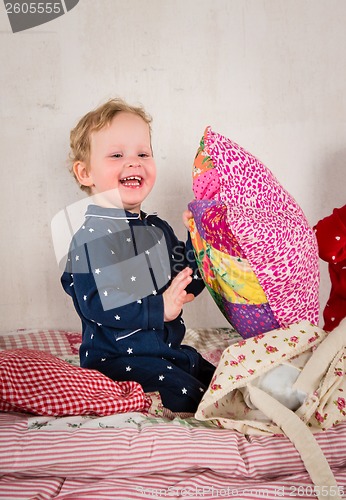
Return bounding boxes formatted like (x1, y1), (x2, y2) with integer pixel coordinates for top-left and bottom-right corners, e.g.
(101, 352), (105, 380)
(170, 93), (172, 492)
(73, 112), (156, 213)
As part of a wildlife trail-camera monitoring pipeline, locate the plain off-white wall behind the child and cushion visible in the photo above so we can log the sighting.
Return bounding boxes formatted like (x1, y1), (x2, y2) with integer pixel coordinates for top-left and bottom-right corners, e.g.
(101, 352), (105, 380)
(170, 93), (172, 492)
(0, 0), (346, 331)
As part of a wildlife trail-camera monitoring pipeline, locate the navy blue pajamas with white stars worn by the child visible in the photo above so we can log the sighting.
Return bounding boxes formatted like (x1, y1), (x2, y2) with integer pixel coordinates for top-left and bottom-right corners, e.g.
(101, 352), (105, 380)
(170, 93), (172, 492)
(61, 205), (215, 412)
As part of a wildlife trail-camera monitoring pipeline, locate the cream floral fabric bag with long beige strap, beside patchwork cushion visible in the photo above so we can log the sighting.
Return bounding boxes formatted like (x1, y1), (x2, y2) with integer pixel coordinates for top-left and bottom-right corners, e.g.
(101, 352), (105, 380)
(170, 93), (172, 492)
(195, 320), (346, 499)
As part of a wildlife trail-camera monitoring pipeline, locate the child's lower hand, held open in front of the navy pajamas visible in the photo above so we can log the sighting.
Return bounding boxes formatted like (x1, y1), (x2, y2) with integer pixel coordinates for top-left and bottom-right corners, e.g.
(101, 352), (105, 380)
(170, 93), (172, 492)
(162, 267), (195, 321)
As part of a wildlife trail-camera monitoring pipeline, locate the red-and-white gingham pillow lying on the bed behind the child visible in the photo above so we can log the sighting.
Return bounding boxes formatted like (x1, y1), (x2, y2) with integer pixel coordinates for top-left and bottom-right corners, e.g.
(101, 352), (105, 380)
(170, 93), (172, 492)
(0, 349), (151, 416)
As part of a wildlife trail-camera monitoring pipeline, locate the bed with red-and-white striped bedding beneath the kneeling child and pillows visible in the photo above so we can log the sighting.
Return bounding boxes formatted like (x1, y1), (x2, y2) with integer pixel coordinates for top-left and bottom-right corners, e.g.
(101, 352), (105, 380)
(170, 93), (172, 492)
(0, 328), (346, 500)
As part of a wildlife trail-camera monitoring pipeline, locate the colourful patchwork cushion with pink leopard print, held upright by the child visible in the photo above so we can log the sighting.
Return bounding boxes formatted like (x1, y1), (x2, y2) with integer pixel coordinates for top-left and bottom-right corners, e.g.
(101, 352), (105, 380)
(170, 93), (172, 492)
(189, 127), (319, 338)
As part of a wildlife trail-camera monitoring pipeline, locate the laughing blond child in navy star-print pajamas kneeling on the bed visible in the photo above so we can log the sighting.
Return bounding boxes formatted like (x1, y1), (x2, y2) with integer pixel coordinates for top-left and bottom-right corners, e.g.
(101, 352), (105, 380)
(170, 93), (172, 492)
(62, 99), (215, 412)
